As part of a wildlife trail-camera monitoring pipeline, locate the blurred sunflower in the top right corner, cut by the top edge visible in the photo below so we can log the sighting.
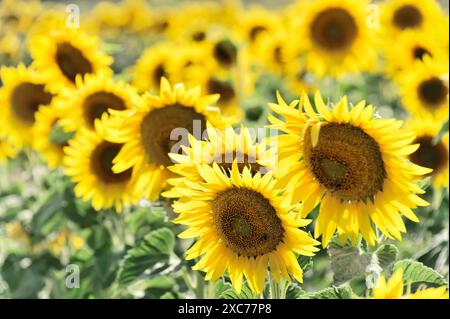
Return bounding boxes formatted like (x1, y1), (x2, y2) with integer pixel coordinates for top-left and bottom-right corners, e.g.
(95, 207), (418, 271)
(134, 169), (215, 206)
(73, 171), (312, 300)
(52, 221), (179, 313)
(381, 0), (445, 35)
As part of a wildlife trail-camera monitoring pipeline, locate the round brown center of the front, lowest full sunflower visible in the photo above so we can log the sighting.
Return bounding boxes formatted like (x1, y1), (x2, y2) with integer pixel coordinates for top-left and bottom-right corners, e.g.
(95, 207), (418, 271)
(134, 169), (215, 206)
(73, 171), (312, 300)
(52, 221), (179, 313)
(212, 188), (284, 257)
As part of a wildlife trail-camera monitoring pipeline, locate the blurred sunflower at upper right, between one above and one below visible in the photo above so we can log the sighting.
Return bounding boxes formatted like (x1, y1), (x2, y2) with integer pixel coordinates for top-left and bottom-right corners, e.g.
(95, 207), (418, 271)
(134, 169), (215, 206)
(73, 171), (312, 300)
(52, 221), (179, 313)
(384, 30), (448, 76)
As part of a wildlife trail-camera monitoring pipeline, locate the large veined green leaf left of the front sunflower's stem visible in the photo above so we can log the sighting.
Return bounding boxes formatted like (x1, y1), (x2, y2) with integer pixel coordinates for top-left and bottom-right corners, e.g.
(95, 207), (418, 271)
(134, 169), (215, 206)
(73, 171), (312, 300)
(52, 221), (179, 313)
(118, 228), (175, 285)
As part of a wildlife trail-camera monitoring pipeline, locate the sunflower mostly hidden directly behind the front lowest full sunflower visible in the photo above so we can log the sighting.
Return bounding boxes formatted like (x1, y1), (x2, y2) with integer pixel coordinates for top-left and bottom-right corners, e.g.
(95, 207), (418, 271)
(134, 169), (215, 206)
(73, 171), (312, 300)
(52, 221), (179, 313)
(163, 123), (275, 192)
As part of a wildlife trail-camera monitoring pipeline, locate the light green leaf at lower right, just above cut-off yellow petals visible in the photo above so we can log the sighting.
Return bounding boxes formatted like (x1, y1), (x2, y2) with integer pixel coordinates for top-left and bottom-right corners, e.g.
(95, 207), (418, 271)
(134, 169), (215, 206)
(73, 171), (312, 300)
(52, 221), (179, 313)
(394, 259), (448, 285)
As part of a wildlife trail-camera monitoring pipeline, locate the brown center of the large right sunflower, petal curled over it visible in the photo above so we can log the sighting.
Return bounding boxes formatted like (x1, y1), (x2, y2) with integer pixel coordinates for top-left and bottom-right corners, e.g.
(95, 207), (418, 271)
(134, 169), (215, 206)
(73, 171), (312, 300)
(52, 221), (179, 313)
(304, 123), (386, 201)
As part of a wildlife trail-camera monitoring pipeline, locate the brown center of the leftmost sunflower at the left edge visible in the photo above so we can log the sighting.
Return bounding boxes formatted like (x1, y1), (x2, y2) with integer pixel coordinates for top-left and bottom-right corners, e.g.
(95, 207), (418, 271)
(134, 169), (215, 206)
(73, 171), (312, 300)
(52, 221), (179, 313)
(10, 82), (53, 124)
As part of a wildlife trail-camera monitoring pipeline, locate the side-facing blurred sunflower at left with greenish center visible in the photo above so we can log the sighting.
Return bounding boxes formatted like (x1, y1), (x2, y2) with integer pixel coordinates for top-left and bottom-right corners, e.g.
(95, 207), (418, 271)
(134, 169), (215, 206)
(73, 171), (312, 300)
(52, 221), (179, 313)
(32, 104), (72, 169)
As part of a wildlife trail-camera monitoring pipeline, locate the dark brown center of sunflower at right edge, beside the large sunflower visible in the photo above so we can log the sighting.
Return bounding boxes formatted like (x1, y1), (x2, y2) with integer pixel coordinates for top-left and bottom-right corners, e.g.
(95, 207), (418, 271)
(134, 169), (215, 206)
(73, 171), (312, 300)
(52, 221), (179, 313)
(409, 135), (449, 175)
